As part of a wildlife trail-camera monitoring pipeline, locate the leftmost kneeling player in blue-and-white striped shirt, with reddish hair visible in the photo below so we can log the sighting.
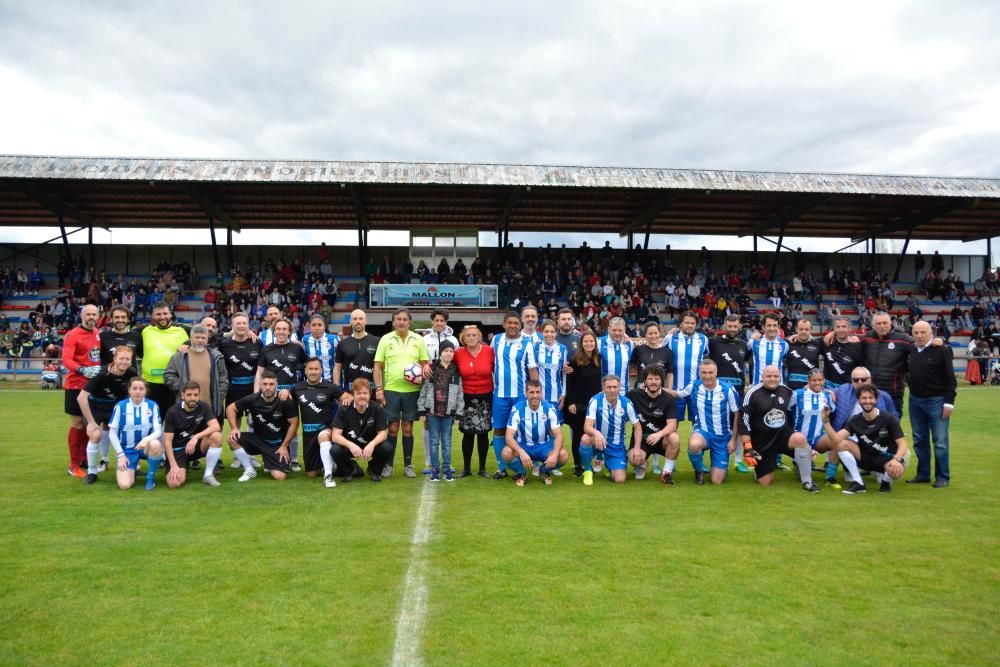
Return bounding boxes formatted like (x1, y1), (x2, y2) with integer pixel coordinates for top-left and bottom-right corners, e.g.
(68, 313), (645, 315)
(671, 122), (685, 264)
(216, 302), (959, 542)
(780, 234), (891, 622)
(108, 377), (163, 491)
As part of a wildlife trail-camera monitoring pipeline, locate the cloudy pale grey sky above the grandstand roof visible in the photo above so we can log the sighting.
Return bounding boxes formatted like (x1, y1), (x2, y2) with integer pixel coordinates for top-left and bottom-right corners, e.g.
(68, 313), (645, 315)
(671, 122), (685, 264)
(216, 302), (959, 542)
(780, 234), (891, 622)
(0, 0), (1000, 252)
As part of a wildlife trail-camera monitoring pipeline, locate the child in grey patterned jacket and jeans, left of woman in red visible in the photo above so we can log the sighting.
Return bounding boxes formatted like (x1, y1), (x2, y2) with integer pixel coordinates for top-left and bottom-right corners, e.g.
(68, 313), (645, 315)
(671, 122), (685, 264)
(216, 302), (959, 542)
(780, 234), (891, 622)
(417, 340), (465, 482)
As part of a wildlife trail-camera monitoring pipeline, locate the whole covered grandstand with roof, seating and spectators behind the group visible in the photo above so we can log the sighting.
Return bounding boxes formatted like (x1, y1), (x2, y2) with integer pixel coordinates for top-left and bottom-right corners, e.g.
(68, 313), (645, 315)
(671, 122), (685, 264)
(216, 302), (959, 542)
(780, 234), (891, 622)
(0, 156), (1000, 381)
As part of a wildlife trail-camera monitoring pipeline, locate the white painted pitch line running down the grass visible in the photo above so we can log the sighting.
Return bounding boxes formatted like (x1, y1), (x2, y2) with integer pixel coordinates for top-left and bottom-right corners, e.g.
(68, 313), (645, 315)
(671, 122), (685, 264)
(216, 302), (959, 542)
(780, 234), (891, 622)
(392, 483), (437, 666)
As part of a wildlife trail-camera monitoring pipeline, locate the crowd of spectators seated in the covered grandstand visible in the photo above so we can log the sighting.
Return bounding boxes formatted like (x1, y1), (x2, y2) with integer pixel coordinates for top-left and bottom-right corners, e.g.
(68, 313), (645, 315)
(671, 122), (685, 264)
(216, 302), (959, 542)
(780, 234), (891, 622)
(0, 242), (1000, 363)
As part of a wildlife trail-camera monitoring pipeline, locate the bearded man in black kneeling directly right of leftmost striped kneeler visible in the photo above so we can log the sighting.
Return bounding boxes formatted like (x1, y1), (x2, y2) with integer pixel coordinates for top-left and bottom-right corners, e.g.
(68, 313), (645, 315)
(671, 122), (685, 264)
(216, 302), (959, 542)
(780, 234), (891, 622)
(163, 384), (222, 489)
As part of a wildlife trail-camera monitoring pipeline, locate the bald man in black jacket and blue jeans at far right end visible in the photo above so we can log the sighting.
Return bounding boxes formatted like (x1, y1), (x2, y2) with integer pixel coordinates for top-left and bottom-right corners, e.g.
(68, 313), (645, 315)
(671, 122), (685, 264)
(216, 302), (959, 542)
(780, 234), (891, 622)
(907, 322), (957, 489)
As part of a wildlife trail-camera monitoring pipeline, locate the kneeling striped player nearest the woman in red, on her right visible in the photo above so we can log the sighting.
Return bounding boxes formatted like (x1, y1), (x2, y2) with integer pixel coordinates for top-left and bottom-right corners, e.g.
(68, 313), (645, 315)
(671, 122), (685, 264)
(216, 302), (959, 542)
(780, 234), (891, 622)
(500, 380), (569, 486)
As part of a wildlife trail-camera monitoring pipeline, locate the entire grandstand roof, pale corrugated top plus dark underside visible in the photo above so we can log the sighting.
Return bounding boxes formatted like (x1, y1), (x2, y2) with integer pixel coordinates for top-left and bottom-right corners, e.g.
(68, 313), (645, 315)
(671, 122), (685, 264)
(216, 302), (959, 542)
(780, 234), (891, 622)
(0, 156), (1000, 240)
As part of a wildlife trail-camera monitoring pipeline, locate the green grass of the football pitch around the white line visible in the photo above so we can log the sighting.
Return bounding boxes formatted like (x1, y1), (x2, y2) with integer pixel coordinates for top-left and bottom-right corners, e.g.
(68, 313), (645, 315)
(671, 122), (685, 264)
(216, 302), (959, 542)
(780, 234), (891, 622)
(0, 387), (1000, 665)
